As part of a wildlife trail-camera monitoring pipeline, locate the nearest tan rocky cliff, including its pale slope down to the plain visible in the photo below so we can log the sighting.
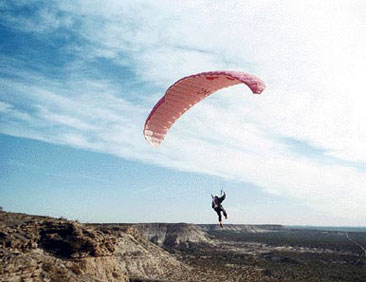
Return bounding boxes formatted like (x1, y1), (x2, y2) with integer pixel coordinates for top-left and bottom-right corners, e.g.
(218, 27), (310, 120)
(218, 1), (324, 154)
(0, 211), (192, 282)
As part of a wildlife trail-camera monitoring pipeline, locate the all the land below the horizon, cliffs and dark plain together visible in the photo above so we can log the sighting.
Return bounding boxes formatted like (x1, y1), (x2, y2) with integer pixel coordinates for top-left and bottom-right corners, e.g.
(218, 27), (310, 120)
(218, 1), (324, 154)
(0, 211), (366, 282)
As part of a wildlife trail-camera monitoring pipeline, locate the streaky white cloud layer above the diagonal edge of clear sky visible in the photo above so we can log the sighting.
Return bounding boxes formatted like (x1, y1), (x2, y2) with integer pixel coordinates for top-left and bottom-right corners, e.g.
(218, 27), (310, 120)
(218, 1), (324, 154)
(0, 1), (366, 224)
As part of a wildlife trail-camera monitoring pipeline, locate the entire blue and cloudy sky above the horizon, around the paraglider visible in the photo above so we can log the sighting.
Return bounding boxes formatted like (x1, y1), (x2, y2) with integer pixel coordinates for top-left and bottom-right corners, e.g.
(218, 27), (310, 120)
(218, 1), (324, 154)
(0, 0), (366, 225)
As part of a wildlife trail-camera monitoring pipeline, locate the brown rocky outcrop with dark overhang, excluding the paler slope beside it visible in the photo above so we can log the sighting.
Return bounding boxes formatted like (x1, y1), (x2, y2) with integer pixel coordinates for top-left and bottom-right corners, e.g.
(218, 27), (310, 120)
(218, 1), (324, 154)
(0, 211), (129, 281)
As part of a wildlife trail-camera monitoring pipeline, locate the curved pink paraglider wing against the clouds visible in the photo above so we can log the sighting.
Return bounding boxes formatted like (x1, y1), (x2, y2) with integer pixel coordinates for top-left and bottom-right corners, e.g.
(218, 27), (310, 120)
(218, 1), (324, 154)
(144, 71), (265, 147)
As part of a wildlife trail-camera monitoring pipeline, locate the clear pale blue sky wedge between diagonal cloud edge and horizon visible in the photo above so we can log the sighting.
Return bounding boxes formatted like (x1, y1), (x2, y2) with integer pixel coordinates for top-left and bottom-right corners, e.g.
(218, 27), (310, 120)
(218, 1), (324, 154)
(0, 135), (312, 223)
